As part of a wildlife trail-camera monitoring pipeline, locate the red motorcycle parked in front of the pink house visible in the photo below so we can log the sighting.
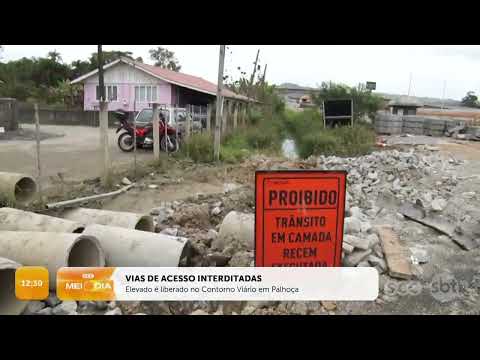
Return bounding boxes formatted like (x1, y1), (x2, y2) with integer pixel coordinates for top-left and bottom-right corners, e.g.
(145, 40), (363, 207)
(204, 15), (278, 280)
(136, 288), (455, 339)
(115, 110), (179, 153)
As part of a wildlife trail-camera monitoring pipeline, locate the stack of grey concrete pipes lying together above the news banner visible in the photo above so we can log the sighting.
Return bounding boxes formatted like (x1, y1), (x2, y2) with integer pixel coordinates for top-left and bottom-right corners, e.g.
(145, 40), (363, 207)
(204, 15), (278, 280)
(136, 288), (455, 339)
(0, 208), (189, 314)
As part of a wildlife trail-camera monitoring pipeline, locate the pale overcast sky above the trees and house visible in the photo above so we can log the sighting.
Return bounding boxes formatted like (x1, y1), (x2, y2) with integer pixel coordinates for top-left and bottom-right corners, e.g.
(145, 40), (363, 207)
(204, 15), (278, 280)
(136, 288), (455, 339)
(1, 45), (480, 100)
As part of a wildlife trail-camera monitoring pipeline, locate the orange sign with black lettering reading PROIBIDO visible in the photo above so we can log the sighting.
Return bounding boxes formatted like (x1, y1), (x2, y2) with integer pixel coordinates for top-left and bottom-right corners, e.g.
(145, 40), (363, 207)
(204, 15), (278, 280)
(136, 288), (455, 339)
(255, 170), (347, 267)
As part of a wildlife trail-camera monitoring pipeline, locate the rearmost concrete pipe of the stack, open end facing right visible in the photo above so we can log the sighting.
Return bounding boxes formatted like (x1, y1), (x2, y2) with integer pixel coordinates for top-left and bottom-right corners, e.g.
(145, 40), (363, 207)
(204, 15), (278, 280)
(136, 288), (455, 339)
(62, 208), (155, 232)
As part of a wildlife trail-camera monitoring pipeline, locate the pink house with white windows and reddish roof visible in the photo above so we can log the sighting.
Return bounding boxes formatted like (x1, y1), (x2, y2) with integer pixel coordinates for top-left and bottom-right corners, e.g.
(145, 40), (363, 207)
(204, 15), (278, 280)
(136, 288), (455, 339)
(72, 58), (248, 112)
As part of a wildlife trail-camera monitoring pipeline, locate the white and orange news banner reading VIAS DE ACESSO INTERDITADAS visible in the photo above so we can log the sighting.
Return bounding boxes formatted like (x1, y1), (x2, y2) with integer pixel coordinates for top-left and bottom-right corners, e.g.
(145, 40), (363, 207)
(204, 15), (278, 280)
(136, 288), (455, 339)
(57, 267), (379, 301)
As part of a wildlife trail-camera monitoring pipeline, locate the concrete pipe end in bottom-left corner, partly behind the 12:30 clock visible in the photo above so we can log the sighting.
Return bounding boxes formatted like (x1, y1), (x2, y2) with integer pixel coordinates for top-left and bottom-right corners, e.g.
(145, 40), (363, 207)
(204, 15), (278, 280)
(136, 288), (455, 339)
(0, 257), (28, 315)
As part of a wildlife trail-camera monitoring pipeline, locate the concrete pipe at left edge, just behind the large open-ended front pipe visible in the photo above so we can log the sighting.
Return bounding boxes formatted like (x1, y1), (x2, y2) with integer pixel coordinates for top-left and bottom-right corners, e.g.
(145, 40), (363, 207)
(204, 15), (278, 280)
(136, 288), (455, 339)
(0, 208), (85, 233)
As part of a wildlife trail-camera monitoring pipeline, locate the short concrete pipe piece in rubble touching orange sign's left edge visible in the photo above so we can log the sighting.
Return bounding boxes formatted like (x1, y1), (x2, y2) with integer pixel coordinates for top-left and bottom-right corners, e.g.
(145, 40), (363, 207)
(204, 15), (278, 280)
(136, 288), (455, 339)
(219, 211), (255, 250)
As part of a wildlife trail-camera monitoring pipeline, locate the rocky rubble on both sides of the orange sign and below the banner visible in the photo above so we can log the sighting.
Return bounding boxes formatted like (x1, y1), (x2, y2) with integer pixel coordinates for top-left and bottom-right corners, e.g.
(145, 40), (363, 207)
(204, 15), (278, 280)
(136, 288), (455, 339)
(10, 146), (477, 315)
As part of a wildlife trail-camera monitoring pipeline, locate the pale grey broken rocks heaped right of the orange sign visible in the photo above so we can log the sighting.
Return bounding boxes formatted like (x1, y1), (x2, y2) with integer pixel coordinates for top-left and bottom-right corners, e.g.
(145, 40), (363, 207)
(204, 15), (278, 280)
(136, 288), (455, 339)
(307, 149), (463, 211)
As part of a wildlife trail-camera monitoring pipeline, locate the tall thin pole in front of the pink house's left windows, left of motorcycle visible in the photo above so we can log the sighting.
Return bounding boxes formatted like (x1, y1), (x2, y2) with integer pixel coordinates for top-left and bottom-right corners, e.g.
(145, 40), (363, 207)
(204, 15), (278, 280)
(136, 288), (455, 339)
(97, 45), (110, 186)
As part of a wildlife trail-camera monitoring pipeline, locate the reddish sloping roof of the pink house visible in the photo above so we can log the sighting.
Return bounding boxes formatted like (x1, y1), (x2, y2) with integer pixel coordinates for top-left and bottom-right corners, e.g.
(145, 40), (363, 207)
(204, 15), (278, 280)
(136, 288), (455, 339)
(72, 58), (255, 101)
